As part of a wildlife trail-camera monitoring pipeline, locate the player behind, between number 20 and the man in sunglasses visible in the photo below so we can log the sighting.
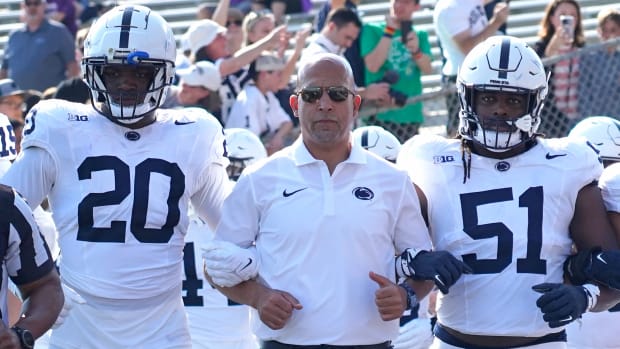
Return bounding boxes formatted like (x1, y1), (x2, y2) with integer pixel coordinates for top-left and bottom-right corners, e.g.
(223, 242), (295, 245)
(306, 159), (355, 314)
(183, 128), (267, 349)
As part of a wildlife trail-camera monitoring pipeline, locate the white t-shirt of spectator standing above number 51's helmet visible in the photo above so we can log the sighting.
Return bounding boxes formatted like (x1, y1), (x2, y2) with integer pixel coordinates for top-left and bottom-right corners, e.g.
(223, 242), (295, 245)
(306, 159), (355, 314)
(433, 0), (489, 76)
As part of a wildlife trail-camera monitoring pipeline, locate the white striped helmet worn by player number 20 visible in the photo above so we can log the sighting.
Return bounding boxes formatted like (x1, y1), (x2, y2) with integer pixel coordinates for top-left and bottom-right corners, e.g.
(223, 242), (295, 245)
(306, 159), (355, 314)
(82, 4), (176, 123)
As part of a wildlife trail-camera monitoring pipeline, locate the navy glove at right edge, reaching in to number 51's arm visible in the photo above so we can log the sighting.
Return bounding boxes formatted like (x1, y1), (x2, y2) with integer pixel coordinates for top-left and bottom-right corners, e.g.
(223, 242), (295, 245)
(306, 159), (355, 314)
(564, 248), (620, 290)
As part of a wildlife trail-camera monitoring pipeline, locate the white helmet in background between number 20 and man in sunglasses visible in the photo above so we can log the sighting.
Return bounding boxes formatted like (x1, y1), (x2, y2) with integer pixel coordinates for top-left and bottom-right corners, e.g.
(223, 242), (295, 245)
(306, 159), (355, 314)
(224, 128), (267, 181)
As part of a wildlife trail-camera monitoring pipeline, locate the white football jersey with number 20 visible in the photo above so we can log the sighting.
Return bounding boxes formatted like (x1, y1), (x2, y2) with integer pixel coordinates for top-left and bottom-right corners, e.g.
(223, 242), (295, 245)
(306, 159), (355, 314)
(13, 100), (229, 299)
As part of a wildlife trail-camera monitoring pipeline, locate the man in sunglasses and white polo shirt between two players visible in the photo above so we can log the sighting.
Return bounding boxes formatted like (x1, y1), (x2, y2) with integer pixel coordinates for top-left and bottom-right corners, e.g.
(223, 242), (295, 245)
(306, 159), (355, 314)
(205, 54), (466, 349)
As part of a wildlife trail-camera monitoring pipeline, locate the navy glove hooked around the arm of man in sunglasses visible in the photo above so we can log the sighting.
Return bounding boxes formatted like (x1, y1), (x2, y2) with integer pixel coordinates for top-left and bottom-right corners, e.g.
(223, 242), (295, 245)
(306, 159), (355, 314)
(396, 248), (472, 294)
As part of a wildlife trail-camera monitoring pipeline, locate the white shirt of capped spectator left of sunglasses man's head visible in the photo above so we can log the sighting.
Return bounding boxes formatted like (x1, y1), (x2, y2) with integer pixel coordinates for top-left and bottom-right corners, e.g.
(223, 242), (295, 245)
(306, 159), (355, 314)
(226, 84), (291, 139)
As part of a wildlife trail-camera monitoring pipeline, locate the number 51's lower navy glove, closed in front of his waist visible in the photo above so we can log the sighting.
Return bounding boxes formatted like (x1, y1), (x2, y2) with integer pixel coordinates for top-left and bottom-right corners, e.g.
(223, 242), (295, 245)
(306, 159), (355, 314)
(532, 283), (588, 328)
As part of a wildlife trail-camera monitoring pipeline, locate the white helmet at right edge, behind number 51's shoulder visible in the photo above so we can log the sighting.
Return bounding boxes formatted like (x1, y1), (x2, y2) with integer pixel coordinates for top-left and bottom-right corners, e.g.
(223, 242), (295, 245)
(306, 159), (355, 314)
(568, 116), (620, 162)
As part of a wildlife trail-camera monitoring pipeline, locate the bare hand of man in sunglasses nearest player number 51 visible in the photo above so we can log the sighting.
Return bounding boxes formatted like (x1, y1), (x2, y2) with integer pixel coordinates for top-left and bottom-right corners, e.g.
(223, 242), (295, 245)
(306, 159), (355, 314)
(368, 271), (407, 321)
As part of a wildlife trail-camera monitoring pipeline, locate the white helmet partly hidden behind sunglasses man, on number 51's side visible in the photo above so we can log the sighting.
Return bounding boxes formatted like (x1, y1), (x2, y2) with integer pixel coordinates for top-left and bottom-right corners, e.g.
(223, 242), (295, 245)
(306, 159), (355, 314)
(353, 126), (401, 162)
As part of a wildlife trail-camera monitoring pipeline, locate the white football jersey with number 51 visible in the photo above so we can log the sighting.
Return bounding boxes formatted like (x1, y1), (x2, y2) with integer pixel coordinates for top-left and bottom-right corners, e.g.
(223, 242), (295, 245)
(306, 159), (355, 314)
(398, 136), (602, 337)
